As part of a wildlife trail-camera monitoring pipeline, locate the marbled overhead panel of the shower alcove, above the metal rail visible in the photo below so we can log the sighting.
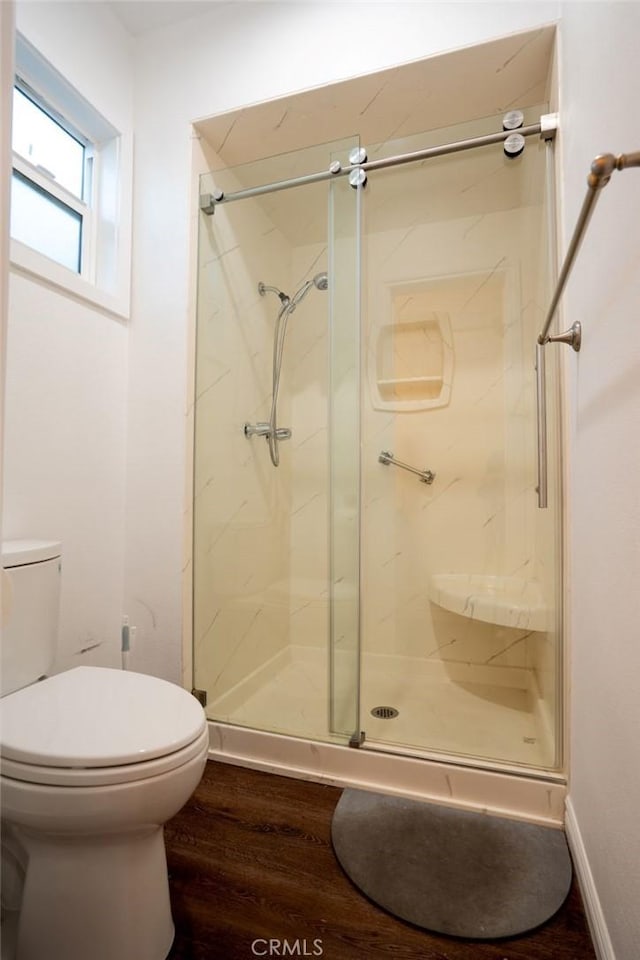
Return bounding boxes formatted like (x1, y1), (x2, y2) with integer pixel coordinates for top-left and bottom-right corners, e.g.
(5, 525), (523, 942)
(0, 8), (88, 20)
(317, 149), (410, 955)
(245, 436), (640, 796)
(197, 24), (555, 166)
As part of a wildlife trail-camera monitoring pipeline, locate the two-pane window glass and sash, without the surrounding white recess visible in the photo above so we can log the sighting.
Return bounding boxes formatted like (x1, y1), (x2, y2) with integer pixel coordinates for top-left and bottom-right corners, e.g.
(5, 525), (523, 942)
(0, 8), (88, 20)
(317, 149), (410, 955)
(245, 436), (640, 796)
(11, 81), (93, 275)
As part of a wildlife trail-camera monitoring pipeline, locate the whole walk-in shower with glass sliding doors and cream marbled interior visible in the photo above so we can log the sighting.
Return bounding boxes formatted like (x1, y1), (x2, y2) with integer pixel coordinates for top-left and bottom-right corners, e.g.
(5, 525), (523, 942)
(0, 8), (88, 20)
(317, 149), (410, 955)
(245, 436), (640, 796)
(193, 103), (562, 775)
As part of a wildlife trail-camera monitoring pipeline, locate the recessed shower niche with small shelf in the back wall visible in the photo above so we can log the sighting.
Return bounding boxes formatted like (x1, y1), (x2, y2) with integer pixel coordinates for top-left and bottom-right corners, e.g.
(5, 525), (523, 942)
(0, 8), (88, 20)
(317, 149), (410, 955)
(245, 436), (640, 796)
(369, 280), (453, 413)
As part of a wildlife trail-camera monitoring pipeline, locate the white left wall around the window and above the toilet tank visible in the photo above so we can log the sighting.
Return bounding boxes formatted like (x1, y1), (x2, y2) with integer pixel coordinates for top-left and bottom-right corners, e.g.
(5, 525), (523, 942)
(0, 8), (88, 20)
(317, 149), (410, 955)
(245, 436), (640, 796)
(3, 3), (133, 669)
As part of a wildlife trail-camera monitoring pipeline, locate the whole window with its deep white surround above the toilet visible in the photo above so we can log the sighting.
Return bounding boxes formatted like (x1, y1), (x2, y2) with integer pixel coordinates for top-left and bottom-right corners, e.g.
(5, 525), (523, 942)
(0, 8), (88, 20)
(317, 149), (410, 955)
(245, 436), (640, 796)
(10, 34), (133, 317)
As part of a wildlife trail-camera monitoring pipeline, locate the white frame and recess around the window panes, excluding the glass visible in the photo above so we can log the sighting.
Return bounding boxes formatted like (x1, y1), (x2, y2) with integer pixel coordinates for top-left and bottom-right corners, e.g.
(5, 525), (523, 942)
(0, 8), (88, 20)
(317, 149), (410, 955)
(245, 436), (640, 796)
(11, 34), (133, 318)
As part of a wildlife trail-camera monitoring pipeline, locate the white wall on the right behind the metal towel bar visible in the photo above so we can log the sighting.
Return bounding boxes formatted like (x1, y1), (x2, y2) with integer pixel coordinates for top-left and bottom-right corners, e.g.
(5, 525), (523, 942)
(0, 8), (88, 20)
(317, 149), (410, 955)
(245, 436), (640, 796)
(560, 3), (640, 960)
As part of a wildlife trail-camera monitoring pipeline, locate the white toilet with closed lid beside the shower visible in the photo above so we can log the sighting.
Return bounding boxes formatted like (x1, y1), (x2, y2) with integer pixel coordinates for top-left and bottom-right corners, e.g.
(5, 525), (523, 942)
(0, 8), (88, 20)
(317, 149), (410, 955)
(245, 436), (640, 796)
(0, 540), (208, 960)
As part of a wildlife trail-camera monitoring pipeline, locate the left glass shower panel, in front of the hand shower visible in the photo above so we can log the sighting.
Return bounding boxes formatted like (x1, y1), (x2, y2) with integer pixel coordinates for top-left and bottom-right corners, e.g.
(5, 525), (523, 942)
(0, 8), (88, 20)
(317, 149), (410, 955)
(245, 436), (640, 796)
(193, 139), (359, 743)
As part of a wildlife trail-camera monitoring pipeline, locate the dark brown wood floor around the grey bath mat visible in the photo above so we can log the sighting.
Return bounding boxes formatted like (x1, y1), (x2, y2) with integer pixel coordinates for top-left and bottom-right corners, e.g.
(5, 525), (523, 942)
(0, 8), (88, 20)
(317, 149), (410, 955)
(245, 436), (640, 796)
(165, 761), (595, 960)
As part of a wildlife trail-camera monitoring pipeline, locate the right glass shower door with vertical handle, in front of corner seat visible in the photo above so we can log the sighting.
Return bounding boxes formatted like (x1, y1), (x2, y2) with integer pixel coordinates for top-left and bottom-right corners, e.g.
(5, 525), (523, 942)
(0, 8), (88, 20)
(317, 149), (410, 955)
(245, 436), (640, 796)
(361, 106), (561, 769)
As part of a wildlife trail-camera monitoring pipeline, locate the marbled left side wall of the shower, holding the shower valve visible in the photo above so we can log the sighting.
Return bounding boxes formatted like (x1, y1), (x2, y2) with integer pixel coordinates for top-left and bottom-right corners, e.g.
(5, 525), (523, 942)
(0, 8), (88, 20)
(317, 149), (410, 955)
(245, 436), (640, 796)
(194, 169), (291, 699)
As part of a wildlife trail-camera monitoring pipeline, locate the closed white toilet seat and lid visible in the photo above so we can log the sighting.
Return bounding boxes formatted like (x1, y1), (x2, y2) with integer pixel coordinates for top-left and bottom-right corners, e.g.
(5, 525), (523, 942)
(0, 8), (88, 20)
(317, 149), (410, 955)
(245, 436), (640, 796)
(0, 667), (207, 786)
